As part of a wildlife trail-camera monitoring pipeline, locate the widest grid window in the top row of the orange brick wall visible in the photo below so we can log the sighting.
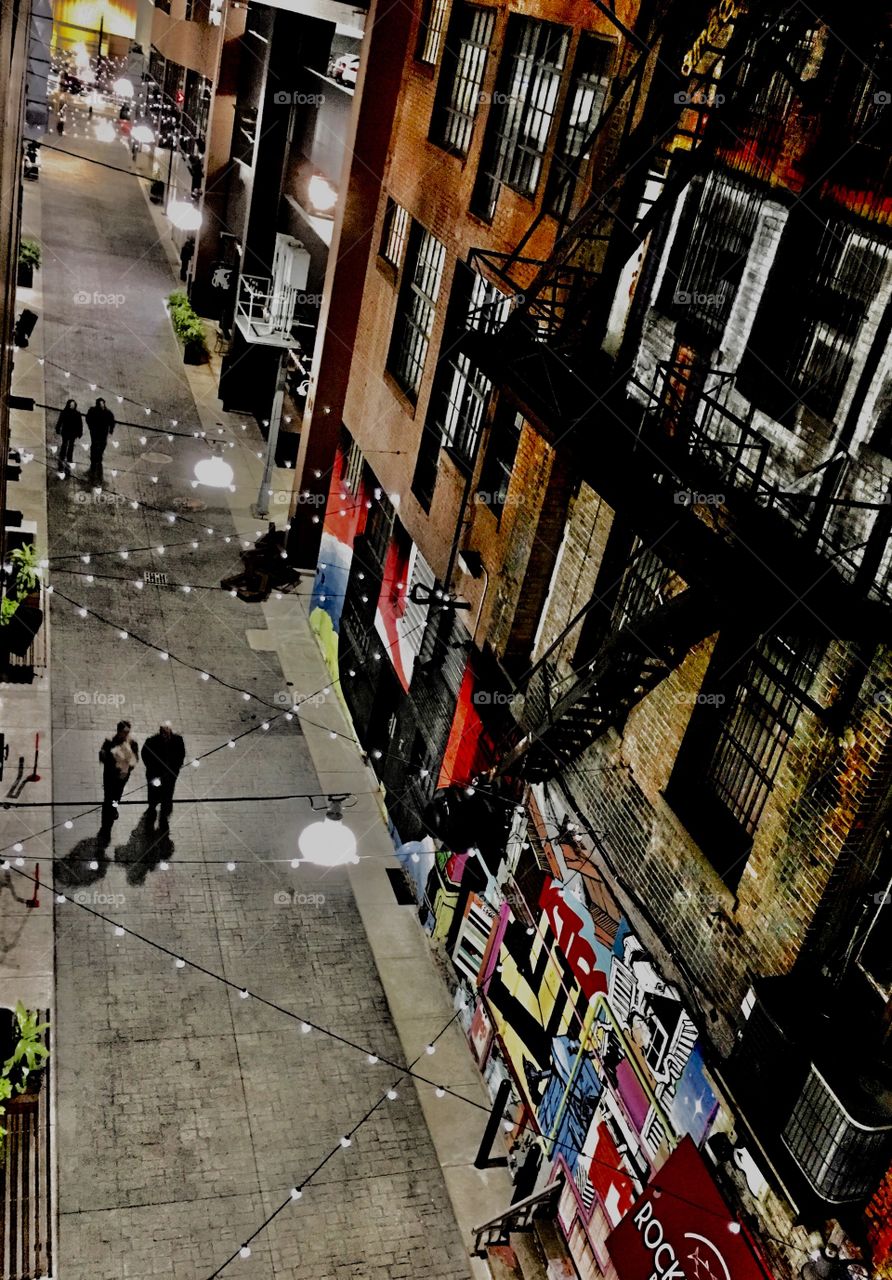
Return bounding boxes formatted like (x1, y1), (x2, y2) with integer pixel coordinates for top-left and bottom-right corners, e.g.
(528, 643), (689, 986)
(472, 15), (569, 221)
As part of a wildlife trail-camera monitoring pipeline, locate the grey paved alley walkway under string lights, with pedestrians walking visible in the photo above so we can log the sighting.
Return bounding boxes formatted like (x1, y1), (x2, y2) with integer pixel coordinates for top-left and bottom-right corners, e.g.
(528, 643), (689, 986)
(13, 124), (509, 1280)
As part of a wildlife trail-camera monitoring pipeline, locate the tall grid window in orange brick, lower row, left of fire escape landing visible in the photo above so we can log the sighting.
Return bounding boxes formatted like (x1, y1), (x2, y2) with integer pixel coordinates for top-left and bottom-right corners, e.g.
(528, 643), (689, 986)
(388, 223), (445, 399)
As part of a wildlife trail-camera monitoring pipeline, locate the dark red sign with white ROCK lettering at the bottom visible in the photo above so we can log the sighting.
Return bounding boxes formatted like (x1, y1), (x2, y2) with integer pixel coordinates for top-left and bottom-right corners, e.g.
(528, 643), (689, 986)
(607, 1137), (770, 1280)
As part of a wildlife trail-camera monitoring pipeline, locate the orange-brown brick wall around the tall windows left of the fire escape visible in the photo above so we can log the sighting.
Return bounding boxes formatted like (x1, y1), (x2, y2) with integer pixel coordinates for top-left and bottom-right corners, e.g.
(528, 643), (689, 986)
(340, 0), (637, 586)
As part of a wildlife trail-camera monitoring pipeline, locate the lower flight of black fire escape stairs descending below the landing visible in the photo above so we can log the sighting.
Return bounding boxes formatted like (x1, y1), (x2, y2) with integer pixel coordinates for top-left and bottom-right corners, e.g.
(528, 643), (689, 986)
(500, 588), (719, 782)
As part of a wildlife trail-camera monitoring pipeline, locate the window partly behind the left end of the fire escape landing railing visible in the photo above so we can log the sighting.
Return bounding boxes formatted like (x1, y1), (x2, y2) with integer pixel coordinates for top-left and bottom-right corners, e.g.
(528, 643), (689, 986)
(412, 264), (511, 506)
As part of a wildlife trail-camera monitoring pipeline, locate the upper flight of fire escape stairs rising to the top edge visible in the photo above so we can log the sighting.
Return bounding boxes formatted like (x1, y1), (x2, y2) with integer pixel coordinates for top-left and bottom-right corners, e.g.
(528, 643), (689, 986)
(462, 0), (810, 407)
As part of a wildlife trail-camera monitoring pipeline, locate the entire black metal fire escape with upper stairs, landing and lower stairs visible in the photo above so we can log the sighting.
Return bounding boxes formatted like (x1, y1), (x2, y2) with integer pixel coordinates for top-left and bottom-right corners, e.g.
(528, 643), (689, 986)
(465, 0), (892, 781)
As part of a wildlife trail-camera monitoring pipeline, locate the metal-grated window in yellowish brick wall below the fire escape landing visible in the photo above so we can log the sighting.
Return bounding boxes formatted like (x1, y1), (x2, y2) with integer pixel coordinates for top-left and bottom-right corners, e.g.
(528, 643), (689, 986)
(704, 636), (818, 836)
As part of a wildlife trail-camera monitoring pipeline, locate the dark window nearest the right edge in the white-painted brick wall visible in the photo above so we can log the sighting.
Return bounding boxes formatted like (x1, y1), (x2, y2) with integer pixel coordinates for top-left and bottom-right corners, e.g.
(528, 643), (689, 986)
(738, 210), (888, 421)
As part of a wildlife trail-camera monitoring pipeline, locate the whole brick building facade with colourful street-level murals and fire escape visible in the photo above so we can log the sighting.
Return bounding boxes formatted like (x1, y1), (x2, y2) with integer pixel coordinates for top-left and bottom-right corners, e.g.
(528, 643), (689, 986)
(292, 0), (892, 1280)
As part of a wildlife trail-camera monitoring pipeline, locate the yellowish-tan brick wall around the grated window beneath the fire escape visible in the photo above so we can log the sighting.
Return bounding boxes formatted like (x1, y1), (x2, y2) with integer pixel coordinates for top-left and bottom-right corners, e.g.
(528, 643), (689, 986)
(514, 485), (892, 1052)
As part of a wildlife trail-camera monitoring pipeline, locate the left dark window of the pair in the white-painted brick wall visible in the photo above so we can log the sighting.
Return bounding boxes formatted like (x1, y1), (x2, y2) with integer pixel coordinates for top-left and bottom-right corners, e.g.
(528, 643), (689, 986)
(659, 173), (763, 342)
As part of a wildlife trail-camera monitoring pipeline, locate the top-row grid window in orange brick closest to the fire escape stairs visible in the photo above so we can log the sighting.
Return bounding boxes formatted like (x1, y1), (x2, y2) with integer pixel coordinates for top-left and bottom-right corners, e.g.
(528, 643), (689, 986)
(548, 32), (613, 218)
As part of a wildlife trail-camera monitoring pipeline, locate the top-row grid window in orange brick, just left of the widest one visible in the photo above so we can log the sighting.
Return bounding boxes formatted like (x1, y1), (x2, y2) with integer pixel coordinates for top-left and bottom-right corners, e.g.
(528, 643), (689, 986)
(430, 4), (495, 156)
